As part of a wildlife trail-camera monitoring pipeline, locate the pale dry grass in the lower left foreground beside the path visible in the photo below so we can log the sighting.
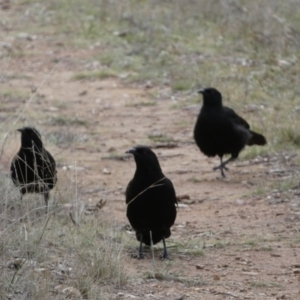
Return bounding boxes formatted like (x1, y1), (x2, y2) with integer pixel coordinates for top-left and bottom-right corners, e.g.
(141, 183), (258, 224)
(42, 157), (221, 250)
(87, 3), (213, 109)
(0, 169), (128, 299)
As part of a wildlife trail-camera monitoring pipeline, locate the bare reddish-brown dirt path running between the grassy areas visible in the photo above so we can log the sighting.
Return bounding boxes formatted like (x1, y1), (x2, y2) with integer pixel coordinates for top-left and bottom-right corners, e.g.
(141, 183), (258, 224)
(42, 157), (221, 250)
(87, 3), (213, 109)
(0, 24), (300, 300)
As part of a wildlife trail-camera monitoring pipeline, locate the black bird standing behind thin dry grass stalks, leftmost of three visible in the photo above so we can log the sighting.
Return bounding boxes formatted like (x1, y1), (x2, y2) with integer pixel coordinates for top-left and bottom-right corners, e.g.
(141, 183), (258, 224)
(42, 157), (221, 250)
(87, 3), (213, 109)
(10, 127), (57, 213)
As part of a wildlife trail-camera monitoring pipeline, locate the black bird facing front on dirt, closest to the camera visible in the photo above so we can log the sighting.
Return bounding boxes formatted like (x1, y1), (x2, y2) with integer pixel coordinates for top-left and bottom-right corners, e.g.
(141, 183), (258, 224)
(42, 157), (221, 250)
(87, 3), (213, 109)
(126, 146), (177, 259)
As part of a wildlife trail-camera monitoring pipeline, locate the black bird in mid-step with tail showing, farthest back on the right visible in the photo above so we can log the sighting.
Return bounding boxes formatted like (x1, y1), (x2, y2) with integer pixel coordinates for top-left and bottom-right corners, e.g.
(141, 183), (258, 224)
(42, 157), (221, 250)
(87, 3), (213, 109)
(194, 88), (267, 177)
